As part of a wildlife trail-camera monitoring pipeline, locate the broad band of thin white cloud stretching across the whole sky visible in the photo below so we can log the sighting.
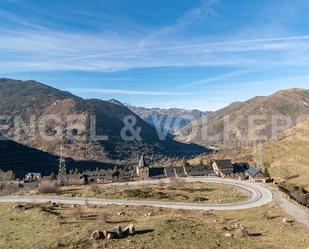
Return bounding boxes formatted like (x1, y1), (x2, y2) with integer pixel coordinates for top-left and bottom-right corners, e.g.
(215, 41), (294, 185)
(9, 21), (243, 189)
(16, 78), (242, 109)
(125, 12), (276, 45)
(0, 27), (309, 72)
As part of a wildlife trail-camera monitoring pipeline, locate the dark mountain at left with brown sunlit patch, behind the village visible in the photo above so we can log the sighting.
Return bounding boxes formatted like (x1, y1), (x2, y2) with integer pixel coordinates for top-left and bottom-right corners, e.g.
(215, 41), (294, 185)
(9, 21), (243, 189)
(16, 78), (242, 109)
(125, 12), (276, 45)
(0, 79), (205, 166)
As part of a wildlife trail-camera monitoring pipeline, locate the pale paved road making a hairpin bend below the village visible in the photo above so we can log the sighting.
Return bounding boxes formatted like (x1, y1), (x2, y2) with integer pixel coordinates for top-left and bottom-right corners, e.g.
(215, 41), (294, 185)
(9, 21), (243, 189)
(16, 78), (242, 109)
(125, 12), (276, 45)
(0, 177), (272, 210)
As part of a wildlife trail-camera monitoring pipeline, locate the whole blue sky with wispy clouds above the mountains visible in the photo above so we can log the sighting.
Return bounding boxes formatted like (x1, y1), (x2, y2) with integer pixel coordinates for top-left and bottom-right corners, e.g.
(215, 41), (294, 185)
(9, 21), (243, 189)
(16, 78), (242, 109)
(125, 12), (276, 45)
(0, 0), (309, 110)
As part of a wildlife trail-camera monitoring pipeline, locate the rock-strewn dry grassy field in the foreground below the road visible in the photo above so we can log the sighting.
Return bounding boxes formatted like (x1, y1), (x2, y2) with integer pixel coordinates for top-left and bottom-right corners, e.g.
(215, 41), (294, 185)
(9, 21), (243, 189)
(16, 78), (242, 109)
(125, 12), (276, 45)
(0, 204), (309, 249)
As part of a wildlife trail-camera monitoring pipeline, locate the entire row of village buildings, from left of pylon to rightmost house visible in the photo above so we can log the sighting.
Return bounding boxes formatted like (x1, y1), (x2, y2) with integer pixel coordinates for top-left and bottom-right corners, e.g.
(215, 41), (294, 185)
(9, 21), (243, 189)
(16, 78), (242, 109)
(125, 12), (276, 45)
(24, 155), (266, 188)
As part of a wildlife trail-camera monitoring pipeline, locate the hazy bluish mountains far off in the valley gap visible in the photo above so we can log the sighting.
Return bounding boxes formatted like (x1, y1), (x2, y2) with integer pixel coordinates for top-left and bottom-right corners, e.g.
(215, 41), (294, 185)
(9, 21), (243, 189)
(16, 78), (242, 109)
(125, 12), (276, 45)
(128, 106), (208, 136)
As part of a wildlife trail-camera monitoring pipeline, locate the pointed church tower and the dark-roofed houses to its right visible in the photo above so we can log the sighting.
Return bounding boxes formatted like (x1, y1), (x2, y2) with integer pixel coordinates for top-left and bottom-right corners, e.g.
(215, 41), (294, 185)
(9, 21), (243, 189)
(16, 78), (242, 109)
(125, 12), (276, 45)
(136, 155), (266, 182)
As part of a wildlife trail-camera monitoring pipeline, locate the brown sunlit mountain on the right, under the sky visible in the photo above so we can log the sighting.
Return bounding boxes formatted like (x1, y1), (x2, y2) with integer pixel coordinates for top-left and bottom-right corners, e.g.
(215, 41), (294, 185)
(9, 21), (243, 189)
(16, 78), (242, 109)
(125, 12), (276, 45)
(177, 89), (309, 148)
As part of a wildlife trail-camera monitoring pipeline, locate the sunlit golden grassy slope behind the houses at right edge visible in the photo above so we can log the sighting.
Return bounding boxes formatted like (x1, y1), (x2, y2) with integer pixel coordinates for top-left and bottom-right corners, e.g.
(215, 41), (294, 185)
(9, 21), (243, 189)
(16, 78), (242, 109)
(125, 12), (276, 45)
(190, 117), (309, 191)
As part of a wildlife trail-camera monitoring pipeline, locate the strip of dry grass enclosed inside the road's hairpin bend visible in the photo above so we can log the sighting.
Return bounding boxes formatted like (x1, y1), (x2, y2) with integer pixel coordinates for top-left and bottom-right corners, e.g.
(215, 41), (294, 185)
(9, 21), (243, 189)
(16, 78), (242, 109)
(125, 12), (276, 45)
(56, 180), (249, 204)
